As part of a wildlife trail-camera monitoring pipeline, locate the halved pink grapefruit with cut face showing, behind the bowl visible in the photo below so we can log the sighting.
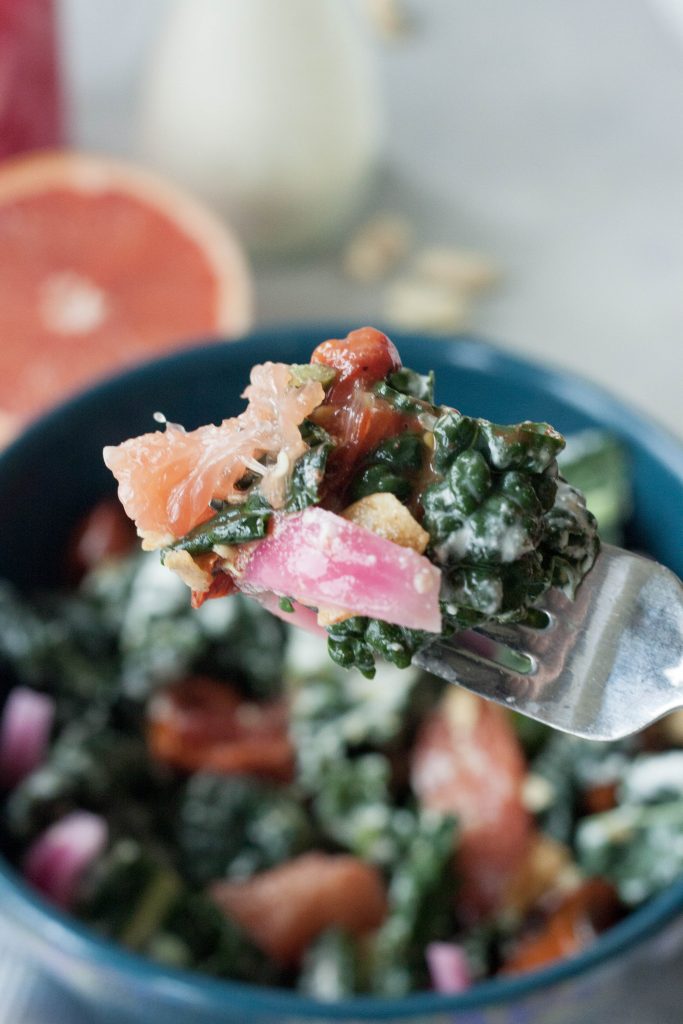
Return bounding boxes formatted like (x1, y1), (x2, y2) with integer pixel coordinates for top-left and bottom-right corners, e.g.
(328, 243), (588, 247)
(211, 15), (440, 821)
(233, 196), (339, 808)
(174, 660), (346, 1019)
(0, 152), (252, 422)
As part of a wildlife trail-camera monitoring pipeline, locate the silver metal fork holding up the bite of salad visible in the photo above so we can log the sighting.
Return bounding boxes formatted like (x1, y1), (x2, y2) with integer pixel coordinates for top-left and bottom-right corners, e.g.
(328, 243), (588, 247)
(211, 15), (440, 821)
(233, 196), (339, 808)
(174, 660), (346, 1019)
(414, 544), (683, 739)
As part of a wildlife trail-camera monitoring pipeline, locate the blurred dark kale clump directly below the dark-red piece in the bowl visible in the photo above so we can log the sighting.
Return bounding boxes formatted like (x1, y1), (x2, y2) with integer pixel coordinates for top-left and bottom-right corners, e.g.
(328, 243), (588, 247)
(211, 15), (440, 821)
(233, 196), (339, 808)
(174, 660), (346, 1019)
(176, 773), (314, 886)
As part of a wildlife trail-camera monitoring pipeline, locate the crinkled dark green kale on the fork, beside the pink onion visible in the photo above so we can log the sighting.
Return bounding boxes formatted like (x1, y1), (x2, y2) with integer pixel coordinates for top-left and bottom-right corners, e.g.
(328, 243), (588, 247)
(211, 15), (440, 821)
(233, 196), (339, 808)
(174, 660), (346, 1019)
(328, 391), (598, 677)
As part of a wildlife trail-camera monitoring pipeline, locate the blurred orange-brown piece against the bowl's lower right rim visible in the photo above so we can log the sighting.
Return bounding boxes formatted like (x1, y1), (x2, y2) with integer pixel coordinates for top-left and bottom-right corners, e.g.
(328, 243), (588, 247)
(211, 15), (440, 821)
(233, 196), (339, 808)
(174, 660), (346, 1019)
(503, 879), (621, 974)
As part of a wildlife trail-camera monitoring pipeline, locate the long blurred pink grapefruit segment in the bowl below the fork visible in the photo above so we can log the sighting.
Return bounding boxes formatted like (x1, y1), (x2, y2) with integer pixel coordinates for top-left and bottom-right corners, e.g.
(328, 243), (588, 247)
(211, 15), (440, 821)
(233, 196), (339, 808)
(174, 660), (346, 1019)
(411, 687), (533, 923)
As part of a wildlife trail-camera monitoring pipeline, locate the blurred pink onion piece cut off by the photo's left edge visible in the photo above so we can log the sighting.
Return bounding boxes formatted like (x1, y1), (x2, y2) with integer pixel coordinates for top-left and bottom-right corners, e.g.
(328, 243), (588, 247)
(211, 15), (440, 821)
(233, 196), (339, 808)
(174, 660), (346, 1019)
(0, 686), (55, 788)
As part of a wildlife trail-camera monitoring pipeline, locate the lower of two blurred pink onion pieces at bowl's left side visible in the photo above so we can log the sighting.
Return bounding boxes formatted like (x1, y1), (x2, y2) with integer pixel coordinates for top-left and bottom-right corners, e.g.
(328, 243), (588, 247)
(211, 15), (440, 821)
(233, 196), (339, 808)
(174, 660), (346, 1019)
(23, 811), (109, 909)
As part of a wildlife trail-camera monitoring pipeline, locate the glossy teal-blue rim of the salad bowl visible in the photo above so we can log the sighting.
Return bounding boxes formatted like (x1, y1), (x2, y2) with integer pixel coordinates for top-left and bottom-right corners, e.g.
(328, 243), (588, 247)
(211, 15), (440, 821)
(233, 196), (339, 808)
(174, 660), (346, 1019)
(0, 322), (683, 1021)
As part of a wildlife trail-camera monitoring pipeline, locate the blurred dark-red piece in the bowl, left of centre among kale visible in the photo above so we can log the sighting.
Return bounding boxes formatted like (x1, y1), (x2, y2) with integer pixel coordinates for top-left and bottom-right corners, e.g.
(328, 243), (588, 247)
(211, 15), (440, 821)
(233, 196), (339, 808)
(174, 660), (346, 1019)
(147, 677), (294, 781)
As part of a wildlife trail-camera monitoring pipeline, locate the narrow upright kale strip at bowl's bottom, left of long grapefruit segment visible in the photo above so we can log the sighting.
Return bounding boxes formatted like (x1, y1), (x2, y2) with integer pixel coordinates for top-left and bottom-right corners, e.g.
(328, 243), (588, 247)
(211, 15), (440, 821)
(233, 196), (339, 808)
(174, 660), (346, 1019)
(370, 810), (457, 996)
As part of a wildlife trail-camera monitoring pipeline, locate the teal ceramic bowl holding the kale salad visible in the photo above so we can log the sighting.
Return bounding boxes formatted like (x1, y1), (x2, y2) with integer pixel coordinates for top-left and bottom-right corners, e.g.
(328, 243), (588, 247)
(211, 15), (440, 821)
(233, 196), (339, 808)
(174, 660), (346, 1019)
(0, 324), (683, 1024)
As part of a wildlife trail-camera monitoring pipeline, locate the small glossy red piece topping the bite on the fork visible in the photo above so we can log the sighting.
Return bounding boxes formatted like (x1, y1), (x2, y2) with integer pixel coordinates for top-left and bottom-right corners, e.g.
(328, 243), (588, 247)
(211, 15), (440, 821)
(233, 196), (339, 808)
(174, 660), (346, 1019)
(310, 327), (400, 404)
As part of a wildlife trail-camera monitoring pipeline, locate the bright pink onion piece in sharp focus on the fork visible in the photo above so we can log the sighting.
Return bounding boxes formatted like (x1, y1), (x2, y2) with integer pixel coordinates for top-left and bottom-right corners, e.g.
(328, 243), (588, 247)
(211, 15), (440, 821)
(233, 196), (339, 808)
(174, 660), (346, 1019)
(240, 508), (441, 633)
